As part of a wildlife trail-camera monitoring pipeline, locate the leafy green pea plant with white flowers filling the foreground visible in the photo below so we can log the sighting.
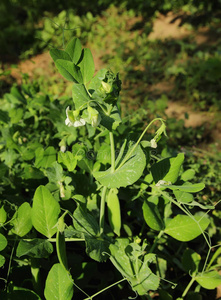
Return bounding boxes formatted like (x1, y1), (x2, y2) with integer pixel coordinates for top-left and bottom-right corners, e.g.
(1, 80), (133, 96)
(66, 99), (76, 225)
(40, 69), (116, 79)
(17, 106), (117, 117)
(0, 38), (221, 300)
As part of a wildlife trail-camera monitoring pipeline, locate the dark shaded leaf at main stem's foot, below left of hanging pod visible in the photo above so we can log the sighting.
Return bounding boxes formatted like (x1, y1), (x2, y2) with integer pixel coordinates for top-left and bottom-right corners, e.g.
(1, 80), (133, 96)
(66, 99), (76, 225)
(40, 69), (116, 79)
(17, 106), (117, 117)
(85, 234), (109, 262)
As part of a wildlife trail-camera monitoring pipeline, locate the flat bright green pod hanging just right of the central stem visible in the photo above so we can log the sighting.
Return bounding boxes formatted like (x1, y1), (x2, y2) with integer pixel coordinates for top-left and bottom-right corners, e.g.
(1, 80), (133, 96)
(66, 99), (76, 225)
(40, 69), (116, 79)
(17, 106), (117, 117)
(107, 188), (121, 236)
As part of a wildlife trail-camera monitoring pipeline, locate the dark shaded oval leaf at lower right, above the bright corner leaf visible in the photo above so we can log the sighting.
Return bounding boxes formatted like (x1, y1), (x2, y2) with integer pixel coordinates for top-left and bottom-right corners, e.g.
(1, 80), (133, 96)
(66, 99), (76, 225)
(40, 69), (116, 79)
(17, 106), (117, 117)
(182, 249), (201, 275)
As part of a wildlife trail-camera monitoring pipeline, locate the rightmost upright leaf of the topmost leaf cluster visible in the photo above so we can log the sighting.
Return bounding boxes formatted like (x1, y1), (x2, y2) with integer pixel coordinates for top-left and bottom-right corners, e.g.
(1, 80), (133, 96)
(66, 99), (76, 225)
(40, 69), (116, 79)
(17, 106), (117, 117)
(78, 48), (95, 85)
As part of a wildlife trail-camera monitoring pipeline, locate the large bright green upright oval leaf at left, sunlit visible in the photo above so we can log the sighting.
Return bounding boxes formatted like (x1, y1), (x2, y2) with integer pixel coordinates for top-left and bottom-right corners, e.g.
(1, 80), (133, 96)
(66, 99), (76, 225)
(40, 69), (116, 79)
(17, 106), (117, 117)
(32, 186), (60, 238)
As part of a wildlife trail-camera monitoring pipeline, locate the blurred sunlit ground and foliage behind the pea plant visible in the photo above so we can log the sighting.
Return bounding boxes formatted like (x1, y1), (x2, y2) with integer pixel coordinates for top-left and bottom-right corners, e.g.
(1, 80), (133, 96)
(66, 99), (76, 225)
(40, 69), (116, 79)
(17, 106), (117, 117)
(0, 0), (221, 202)
